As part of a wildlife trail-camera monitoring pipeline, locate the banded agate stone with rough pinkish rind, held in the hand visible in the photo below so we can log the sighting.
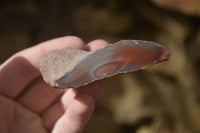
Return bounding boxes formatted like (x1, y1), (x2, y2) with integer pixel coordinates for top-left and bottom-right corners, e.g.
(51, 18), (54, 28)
(40, 40), (171, 88)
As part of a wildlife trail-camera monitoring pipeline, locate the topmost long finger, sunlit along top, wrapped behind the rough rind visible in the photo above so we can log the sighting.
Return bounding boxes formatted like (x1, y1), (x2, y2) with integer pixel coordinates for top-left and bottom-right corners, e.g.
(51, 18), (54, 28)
(0, 36), (85, 98)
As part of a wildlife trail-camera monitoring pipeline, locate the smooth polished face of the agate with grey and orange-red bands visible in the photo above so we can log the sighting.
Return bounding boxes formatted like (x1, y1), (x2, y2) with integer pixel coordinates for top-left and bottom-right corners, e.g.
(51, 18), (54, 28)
(53, 40), (171, 88)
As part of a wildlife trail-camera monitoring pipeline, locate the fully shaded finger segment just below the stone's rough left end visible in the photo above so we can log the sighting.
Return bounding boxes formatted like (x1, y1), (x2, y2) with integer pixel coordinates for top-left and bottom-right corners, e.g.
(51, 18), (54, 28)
(16, 78), (65, 114)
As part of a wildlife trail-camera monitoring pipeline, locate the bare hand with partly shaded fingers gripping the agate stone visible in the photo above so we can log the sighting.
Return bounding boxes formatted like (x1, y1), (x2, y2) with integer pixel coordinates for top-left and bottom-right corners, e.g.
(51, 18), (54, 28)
(0, 36), (108, 133)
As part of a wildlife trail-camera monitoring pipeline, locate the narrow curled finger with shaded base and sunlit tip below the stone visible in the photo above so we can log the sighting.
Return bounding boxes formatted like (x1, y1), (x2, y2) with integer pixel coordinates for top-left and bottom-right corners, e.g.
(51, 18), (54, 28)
(41, 88), (77, 131)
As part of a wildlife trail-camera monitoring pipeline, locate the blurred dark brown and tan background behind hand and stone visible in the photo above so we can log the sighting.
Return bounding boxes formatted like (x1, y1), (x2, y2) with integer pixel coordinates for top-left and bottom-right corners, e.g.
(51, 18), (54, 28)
(0, 0), (200, 133)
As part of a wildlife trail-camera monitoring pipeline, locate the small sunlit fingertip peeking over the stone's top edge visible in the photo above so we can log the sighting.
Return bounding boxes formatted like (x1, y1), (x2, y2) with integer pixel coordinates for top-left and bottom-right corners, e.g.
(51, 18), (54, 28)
(86, 39), (108, 51)
